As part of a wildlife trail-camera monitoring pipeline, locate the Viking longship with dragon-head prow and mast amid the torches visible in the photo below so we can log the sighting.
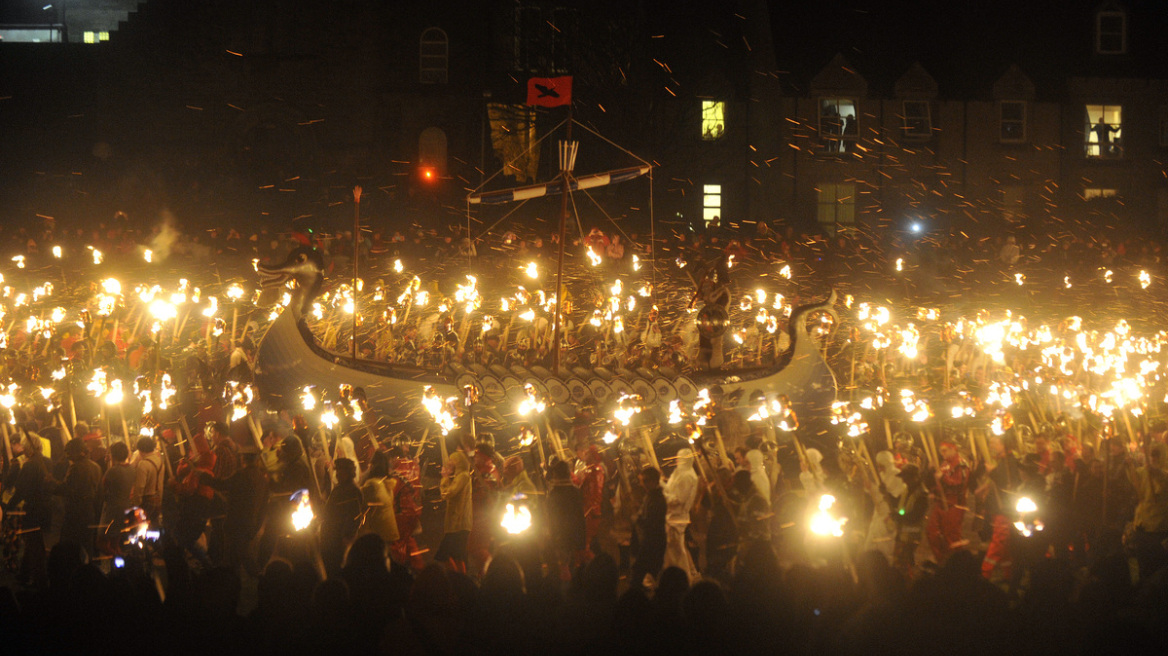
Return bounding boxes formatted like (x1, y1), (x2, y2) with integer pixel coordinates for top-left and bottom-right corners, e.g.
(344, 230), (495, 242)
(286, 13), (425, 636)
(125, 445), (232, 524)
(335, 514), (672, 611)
(256, 121), (836, 437)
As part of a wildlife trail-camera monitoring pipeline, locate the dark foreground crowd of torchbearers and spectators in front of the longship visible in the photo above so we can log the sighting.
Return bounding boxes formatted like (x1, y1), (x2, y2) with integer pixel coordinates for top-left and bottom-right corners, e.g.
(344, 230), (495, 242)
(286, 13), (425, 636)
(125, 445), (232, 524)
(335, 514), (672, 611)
(0, 399), (1168, 654)
